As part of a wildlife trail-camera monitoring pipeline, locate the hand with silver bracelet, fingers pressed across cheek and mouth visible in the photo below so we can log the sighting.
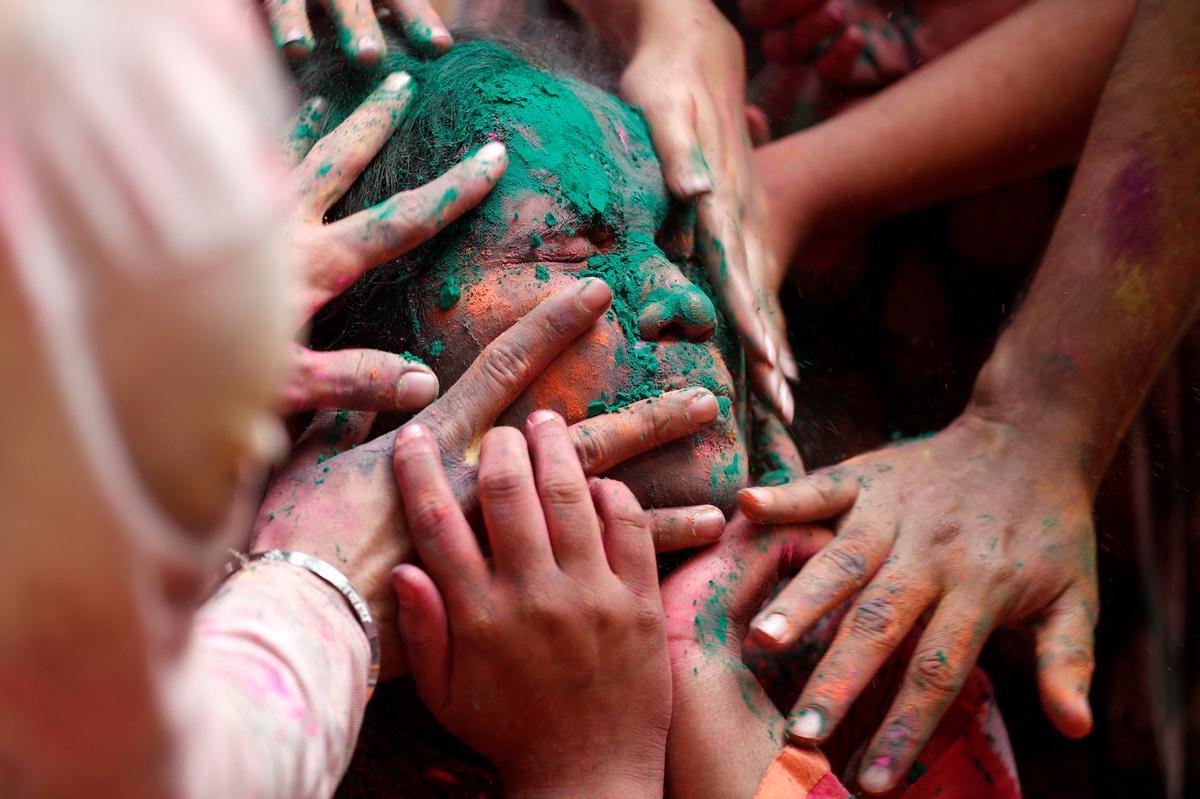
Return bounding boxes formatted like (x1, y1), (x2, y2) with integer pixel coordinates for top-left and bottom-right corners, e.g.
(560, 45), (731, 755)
(258, 278), (725, 678)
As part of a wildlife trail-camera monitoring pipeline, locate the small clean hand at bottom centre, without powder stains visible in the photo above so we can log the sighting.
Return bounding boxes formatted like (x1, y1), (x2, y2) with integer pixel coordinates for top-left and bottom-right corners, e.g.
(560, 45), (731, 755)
(392, 410), (671, 797)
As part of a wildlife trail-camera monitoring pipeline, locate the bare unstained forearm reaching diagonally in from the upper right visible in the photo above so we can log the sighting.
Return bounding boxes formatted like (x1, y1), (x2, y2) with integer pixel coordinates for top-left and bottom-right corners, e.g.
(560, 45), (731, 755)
(756, 0), (1134, 262)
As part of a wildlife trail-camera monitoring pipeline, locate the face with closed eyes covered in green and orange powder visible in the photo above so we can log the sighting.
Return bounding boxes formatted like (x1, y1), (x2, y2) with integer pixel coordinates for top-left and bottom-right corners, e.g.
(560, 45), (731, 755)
(314, 42), (748, 509)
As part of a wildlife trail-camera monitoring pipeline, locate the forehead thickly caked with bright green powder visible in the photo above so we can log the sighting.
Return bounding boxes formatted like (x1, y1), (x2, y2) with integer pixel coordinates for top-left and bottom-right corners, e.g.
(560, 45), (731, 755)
(496, 67), (667, 226)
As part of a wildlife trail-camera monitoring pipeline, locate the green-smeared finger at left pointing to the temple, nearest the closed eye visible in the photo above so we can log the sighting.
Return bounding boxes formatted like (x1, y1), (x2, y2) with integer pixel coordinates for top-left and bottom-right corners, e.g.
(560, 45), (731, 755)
(321, 142), (509, 287)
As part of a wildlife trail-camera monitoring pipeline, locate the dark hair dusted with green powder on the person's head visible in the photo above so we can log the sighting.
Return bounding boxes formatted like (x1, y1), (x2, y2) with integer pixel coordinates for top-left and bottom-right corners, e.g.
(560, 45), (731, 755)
(294, 14), (614, 349)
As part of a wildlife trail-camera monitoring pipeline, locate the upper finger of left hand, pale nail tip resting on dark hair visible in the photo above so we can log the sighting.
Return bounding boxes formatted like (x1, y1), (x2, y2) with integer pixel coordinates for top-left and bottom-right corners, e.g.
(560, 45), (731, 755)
(292, 72), (413, 222)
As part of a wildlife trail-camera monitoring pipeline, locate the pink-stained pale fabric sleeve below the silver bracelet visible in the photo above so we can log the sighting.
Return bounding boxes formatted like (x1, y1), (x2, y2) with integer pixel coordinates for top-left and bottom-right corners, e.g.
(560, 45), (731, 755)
(169, 563), (371, 799)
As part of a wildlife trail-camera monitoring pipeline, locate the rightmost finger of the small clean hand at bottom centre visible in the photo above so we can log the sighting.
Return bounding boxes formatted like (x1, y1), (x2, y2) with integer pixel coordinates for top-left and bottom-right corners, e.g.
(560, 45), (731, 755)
(589, 477), (659, 587)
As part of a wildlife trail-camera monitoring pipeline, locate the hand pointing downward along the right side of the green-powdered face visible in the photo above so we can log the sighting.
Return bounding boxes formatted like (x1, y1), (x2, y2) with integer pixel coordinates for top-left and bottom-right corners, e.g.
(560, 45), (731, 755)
(620, 0), (798, 422)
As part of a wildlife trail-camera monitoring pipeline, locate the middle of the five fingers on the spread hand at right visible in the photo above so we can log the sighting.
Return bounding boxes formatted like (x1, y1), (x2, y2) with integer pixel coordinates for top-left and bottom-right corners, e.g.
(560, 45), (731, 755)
(787, 571), (944, 743)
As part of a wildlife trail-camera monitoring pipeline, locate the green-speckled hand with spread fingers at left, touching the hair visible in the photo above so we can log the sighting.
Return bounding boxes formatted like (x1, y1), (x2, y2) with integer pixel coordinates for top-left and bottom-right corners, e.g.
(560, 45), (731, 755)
(283, 73), (508, 411)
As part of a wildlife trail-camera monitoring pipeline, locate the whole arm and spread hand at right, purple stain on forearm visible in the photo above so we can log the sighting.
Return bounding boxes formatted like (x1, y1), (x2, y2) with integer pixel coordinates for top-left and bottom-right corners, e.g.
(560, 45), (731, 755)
(742, 0), (1200, 792)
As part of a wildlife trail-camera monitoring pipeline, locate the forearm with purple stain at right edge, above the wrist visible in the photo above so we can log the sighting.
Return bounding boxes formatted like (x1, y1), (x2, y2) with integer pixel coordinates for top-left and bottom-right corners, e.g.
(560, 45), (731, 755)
(972, 0), (1200, 488)
